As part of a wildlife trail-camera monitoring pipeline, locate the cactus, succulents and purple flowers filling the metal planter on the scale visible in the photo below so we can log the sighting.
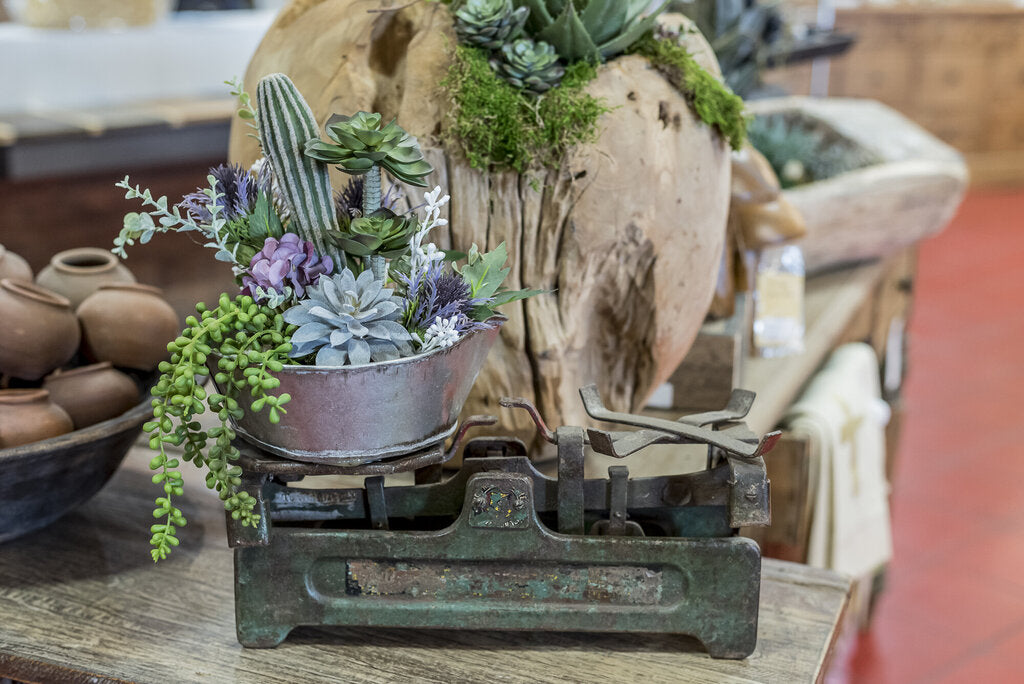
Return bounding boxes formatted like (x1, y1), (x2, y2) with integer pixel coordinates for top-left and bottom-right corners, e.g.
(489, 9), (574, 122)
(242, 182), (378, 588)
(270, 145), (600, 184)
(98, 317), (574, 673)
(113, 74), (537, 560)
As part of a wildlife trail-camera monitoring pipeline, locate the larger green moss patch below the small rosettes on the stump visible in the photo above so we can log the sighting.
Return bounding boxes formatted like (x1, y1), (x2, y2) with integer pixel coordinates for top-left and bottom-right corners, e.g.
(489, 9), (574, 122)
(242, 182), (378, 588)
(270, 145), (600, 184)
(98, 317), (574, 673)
(441, 45), (608, 173)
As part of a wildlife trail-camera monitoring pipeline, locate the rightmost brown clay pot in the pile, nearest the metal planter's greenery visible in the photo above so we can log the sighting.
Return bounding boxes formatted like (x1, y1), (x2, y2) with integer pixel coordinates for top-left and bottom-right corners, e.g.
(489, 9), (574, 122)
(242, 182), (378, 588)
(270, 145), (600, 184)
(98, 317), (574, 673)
(77, 284), (180, 371)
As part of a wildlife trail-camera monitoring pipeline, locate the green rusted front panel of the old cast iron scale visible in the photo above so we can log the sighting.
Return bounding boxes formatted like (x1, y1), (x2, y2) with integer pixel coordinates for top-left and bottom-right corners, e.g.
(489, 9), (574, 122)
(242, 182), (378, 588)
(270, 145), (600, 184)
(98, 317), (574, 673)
(236, 472), (761, 657)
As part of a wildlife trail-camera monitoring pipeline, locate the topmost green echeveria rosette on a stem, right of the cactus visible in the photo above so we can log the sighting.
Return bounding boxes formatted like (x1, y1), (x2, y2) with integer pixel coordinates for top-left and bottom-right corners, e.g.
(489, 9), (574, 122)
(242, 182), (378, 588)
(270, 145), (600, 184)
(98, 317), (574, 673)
(305, 112), (433, 187)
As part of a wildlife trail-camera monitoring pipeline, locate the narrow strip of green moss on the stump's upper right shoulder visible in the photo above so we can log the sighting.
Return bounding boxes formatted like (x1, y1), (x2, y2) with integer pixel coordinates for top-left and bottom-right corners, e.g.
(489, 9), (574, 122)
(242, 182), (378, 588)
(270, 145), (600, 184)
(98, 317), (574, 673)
(631, 34), (748, 149)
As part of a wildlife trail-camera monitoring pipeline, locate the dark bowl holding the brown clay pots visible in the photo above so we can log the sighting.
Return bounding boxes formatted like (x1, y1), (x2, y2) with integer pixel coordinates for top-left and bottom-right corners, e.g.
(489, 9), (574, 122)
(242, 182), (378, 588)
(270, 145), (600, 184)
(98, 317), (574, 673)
(0, 396), (153, 543)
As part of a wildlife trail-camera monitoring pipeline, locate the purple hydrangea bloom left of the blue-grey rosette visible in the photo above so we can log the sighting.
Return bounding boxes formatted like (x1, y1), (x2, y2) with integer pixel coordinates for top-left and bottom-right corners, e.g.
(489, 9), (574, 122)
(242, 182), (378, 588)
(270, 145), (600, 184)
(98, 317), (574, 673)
(242, 232), (334, 299)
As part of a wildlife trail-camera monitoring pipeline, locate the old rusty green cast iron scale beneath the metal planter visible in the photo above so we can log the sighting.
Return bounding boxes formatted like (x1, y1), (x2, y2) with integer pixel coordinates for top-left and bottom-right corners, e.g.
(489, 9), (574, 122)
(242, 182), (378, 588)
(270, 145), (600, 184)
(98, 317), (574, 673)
(227, 386), (778, 658)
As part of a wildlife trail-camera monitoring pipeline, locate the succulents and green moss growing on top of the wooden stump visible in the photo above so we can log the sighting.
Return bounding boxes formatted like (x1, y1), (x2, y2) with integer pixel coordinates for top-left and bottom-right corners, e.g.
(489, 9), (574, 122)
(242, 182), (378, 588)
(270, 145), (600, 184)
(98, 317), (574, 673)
(441, 0), (745, 173)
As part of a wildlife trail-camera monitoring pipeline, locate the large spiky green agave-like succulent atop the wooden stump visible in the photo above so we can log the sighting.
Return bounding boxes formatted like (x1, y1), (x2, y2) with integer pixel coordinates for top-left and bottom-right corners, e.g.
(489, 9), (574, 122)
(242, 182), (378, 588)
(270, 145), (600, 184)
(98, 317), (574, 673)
(515, 0), (669, 63)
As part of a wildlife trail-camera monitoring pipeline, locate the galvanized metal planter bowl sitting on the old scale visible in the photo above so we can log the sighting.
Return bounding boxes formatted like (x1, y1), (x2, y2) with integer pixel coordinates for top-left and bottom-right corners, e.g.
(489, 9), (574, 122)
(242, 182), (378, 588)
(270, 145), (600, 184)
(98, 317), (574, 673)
(221, 318), (505, 465)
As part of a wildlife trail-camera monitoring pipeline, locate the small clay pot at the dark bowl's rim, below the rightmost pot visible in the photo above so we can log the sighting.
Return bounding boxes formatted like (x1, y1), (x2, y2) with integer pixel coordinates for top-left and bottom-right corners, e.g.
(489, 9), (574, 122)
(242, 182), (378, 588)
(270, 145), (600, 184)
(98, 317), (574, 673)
(43, 361), (139, 430)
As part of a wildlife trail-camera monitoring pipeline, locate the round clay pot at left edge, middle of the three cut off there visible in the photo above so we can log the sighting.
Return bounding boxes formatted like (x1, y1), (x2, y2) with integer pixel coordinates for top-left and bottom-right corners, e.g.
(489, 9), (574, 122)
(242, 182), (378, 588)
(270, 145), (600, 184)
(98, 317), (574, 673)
(0, 279), (82, 380)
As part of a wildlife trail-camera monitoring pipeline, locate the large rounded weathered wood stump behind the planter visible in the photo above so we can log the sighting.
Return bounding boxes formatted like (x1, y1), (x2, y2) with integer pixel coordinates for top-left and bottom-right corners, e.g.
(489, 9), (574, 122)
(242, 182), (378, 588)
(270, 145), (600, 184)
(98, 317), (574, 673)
(230, 0), (730, 440)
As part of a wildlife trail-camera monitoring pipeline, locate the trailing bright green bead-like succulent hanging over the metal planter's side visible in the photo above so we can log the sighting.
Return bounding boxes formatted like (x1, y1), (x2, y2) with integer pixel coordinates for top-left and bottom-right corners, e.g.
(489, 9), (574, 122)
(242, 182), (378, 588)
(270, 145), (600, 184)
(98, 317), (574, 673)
(142, 294), (295, 561)
